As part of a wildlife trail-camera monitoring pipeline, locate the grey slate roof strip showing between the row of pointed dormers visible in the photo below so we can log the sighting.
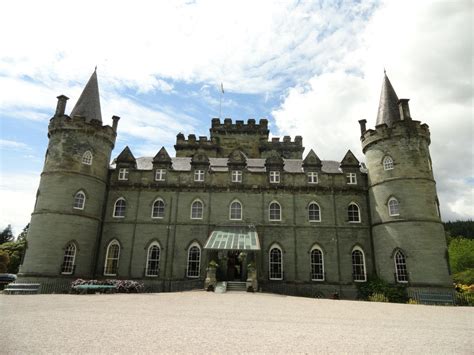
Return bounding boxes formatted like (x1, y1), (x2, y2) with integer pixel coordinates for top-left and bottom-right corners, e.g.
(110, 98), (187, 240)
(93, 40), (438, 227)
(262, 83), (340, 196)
(111, 157), (367, 174)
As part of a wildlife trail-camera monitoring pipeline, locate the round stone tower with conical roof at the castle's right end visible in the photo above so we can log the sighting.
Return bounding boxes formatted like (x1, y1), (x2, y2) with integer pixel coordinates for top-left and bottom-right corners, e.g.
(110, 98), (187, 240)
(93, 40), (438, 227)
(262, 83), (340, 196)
(360, 75), (452, 287)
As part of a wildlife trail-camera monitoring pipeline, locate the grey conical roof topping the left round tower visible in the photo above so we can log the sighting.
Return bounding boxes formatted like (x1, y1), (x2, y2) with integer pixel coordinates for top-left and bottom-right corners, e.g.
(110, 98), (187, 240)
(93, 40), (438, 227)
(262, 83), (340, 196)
(70, 70), (102, 122)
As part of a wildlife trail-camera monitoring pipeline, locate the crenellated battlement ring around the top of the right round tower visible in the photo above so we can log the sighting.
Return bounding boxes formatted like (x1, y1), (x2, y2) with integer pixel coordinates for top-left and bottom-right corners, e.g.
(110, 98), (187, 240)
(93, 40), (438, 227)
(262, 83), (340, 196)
(360, 119), (430, 152)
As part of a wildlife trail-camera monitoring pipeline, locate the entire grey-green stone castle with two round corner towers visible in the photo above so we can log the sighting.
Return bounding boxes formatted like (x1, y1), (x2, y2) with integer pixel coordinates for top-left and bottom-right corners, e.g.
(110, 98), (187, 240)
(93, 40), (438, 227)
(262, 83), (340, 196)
(19, 72), (452, 298)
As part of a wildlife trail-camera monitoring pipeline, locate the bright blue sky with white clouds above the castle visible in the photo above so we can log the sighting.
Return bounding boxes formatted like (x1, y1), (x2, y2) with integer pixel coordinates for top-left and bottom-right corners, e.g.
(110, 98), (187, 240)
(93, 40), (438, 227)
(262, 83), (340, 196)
(0, 0), (474, 235)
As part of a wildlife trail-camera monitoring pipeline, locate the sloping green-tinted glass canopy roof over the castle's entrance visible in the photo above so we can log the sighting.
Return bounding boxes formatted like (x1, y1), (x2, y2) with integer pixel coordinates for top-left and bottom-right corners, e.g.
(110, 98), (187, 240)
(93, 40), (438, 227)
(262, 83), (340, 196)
(204, 226), (260, 250)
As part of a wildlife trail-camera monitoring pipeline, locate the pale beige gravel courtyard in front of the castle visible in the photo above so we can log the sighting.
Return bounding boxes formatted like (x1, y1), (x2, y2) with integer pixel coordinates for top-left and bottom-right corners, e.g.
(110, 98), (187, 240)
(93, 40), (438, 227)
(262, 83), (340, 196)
(0, 291), (474, 354)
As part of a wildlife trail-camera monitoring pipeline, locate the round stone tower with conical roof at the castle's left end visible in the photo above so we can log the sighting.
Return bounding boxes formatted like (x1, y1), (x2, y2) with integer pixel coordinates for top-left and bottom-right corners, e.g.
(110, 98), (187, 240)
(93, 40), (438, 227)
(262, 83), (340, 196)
(19, 71), (119, 286)
